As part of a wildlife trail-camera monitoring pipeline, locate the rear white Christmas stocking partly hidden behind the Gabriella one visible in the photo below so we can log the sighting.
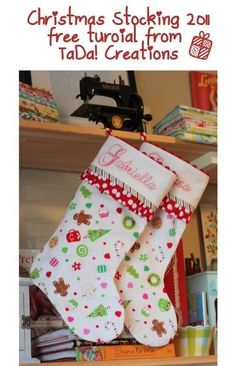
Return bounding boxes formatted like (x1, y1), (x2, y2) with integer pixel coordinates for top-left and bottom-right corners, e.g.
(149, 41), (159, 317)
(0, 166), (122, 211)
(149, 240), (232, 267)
(115, 142), (209, 347)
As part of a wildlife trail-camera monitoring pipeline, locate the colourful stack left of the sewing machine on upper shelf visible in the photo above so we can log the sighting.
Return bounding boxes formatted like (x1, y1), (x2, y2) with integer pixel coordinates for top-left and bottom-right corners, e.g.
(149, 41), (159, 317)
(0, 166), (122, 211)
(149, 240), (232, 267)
(19, 82), (59, 122)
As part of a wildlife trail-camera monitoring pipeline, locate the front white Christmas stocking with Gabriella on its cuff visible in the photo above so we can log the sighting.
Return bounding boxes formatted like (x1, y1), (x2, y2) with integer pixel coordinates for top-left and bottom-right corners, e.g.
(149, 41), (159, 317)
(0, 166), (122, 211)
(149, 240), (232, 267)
(31, 136), (176, 342)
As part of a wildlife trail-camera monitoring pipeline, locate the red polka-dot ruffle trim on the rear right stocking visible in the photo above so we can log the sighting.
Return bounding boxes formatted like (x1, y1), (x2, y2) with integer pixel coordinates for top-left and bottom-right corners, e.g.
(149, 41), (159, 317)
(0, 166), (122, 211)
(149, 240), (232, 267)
(159, 192), (194, 224)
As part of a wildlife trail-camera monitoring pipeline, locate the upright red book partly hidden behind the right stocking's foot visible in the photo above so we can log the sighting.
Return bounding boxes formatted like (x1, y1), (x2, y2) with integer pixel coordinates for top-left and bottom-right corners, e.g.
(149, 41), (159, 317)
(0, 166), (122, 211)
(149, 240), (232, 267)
(164, 240), (188, 327)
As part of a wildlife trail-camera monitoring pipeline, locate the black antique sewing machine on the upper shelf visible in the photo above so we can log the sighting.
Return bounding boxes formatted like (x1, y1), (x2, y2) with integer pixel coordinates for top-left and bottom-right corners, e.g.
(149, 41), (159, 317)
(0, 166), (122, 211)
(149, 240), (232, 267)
(71, 75), (152, 132)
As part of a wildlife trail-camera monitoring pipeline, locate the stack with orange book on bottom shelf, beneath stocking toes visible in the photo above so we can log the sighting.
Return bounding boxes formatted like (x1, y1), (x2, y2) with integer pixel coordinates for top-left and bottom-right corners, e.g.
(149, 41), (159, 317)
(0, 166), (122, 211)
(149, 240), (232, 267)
(32, 328), (175, 362)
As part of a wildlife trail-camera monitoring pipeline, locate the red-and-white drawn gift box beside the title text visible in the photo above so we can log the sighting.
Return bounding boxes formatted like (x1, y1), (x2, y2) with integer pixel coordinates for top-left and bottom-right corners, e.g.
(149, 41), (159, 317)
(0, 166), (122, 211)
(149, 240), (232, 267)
(189, 31), (212, 60)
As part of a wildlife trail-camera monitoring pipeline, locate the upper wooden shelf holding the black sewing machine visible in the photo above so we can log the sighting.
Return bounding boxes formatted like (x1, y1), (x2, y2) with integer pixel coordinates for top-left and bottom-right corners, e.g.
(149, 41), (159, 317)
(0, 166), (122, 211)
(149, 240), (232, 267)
(20, 120), (216, 183)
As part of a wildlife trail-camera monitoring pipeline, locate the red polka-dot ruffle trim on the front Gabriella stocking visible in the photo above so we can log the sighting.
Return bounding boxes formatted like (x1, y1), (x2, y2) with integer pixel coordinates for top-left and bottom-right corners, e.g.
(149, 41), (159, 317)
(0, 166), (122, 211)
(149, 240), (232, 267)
(81, 166), (156, 222)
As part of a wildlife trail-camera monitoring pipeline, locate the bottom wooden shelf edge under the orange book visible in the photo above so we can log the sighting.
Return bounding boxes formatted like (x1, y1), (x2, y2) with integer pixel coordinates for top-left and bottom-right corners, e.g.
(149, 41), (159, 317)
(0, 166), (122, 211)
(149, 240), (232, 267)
(20, 356), (217, 366)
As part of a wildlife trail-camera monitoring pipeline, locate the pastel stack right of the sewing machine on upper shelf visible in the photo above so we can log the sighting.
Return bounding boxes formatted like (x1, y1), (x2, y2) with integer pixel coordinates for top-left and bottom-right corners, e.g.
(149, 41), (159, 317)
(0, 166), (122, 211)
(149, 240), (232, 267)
(153, 105), (217, 145)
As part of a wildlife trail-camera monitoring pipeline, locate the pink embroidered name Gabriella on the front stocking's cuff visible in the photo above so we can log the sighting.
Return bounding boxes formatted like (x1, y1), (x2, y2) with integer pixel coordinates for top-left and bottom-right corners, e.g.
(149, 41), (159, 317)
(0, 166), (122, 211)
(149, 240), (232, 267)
(98, 144), (157, 190)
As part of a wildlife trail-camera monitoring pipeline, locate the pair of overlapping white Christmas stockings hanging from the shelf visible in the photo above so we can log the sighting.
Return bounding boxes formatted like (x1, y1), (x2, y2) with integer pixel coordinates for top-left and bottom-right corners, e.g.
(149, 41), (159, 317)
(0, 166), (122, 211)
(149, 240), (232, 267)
(31, 136), (208, 346)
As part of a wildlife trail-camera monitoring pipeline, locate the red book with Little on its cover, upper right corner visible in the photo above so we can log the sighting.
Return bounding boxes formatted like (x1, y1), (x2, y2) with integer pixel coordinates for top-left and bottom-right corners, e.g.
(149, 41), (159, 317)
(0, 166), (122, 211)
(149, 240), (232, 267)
(190, 71), (217, 112)
